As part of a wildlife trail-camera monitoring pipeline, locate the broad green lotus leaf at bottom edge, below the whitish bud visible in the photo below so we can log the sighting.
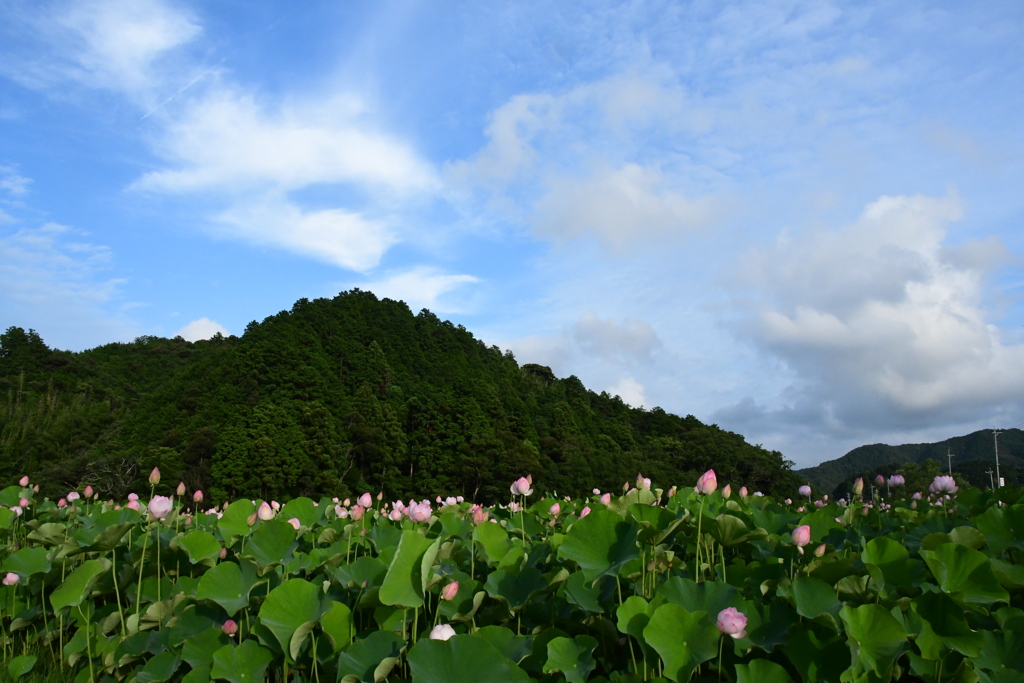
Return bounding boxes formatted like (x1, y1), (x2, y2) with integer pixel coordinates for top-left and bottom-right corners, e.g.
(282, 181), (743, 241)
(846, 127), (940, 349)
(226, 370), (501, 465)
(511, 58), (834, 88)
(408, 635), (529, 683)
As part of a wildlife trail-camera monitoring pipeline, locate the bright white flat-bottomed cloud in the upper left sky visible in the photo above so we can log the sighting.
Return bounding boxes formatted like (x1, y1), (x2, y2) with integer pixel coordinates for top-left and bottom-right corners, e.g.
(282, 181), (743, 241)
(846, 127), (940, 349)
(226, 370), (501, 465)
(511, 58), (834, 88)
(134, 89), (433, 193)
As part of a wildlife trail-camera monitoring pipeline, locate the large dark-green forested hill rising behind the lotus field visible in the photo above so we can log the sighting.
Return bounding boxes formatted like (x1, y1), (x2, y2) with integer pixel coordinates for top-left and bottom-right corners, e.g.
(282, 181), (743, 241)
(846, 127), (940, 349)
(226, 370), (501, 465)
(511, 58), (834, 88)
(0, 290), (797, 502)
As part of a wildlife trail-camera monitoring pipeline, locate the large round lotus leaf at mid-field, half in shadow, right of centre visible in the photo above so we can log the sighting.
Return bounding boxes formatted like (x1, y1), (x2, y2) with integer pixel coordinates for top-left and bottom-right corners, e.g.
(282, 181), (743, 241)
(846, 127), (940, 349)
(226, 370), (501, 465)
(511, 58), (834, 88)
(558, 510), (640, 582)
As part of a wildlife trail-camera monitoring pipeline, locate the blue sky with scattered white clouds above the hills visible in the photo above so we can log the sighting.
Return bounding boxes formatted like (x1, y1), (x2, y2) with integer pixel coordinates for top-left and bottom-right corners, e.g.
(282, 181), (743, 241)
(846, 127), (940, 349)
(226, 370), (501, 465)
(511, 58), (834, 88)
(0, 0), (1024, 466)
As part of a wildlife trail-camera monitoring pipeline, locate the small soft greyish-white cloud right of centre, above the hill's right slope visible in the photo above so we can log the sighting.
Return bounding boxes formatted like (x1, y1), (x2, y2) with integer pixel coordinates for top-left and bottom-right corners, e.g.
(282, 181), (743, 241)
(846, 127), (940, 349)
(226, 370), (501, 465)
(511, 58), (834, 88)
(537, 164), (721, 249)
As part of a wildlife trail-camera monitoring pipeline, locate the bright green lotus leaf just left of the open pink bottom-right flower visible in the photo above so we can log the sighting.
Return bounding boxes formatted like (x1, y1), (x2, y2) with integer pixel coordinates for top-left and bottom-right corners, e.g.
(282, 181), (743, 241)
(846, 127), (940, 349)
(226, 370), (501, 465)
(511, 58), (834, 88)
(643, 602), (722, 683)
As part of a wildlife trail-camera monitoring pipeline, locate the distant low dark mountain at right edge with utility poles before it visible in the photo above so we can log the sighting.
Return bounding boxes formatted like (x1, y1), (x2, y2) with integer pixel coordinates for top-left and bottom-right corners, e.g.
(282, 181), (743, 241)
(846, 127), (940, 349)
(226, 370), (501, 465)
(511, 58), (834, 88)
(797, 429), (1024, 496)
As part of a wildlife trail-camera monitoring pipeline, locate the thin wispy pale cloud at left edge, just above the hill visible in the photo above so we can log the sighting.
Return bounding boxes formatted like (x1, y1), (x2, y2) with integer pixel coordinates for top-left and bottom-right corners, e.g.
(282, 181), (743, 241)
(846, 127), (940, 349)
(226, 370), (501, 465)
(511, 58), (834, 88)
(0, 223), (137, 350)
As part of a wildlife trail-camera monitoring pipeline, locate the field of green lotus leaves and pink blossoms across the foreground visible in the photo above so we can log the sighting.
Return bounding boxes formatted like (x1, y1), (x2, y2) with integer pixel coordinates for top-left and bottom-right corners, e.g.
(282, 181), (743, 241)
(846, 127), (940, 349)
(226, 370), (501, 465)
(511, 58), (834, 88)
(0, 471), (1024, 683)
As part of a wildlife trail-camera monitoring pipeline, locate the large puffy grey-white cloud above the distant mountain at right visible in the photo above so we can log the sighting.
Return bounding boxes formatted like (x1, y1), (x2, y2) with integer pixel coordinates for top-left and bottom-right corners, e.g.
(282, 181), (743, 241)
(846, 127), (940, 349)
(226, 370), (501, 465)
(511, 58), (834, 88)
(741, 191), (1024, 428)
